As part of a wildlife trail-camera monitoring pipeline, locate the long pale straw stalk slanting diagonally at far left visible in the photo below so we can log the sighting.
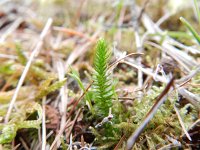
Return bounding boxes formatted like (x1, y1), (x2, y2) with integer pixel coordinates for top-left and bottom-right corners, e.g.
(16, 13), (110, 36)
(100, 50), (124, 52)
(5, 18), (53, 123)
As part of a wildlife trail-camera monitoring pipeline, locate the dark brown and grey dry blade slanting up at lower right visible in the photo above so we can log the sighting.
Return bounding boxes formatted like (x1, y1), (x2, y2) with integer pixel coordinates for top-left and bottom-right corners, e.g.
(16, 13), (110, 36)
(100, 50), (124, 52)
(127, 78), (174, 150)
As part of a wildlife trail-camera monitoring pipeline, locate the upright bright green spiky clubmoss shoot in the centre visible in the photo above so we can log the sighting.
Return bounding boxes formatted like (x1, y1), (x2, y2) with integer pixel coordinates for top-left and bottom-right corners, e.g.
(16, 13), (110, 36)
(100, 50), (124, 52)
(93, 39), (113, 117)
